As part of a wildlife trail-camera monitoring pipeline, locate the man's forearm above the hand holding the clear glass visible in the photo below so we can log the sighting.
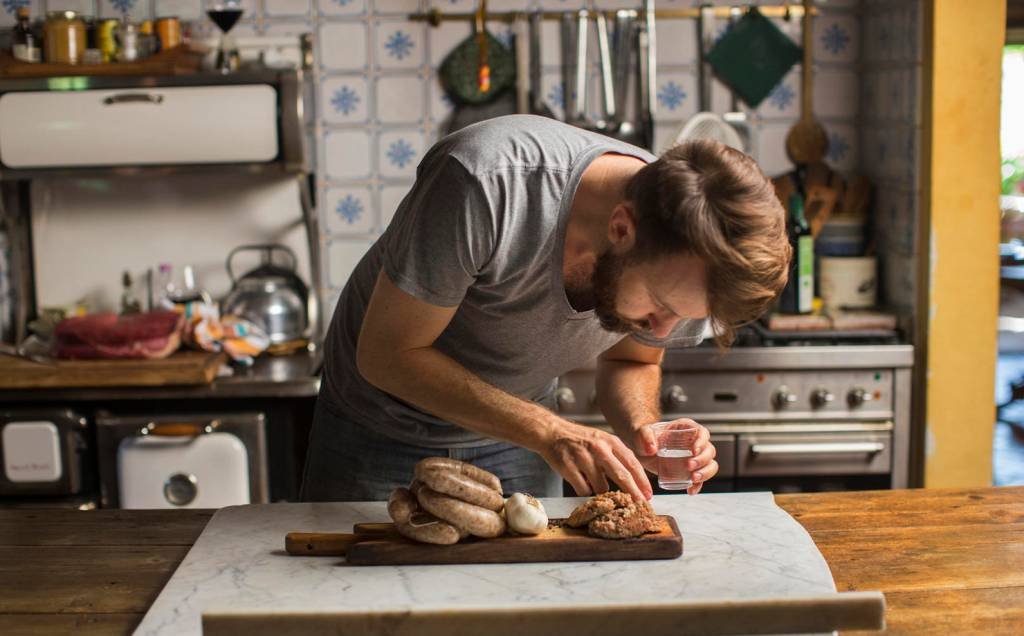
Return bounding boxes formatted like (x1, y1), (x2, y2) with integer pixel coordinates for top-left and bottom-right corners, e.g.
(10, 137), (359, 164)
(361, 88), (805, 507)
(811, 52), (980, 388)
(597, 359), (662, 447)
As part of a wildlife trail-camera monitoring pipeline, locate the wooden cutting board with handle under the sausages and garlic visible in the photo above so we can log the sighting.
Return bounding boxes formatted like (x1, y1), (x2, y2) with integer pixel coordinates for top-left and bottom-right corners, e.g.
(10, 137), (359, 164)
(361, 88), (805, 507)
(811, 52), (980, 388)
(285, 515), (683, 565)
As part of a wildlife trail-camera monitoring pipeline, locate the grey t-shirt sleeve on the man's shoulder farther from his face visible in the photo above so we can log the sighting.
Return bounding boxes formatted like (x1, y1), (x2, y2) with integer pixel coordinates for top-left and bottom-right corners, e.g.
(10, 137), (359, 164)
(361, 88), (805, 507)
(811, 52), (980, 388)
(382, 157), (495, 307)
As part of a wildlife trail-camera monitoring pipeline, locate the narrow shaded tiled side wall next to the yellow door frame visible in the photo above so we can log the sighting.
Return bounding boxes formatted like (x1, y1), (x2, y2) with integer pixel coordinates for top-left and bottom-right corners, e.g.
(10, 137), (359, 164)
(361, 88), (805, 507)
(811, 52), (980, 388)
(860, 0), (923, 327)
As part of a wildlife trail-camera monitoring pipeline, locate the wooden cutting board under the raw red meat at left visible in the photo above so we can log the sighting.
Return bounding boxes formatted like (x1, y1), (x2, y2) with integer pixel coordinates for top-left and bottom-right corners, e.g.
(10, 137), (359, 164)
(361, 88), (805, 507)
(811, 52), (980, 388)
(0, 351), (226, 389)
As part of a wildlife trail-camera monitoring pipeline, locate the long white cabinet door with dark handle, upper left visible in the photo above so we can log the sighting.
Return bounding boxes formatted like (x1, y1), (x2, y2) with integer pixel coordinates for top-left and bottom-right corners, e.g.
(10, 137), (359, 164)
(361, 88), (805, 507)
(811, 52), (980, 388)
(0, 84), (279, 169)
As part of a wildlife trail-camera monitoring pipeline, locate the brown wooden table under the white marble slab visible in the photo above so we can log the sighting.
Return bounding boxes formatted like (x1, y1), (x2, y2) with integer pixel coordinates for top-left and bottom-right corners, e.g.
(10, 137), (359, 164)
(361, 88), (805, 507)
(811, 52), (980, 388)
(0, 486), (1024, 636)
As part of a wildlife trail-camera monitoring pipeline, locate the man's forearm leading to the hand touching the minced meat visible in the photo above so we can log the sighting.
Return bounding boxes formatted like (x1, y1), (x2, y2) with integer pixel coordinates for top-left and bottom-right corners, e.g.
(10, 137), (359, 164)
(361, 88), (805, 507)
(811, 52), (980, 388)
(365, 347), (561, 451)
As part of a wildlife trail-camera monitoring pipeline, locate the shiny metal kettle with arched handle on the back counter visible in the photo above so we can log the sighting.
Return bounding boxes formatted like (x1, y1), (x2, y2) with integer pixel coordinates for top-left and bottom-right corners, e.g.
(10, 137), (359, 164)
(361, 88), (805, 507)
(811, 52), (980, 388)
(220, 244), (309, 344)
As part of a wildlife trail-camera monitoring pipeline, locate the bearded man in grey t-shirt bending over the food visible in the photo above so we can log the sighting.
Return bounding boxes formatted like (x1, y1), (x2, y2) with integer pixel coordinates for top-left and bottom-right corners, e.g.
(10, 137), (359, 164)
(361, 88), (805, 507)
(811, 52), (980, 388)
(302, 116), (790, 501)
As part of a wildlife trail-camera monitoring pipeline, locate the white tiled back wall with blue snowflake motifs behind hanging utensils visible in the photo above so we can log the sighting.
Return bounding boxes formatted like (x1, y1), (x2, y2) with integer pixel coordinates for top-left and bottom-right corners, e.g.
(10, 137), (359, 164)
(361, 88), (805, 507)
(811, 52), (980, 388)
(0, 0), (864, 319)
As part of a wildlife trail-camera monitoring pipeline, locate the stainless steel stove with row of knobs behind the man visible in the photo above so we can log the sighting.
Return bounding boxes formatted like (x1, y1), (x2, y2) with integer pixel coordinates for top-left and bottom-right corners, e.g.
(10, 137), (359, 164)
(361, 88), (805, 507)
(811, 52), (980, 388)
(557, 338), (913, 493)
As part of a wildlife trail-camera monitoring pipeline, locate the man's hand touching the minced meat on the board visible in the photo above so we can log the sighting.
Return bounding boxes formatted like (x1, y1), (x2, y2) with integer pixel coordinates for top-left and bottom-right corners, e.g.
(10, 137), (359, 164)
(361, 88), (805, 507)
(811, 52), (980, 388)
(538, 421), (653, 500)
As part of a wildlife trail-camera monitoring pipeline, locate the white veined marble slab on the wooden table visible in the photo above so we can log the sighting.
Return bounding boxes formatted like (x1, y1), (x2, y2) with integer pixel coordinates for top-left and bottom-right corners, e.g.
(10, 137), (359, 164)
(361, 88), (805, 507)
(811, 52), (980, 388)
(128, 493), (880, 634)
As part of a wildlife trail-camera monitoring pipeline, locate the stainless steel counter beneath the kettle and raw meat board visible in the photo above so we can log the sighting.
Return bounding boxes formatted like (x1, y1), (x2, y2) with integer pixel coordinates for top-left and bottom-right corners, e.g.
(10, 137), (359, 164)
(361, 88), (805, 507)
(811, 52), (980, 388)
(0, 353), (321, 404)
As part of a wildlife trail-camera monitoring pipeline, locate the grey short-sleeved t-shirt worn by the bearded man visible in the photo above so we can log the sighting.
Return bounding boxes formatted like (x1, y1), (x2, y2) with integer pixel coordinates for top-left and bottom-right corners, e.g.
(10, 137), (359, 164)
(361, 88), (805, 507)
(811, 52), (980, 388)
(321, 116), (705, 448)
